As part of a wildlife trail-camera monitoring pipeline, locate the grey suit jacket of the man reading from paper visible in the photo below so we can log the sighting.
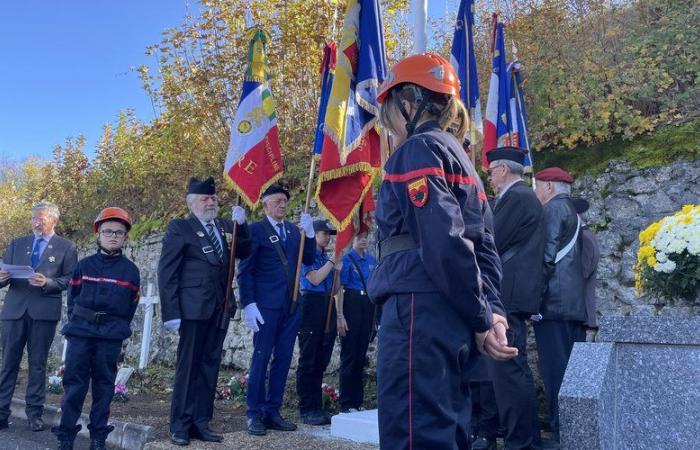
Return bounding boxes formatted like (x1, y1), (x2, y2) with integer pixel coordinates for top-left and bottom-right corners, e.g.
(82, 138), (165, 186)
(0, 235), (78, 320)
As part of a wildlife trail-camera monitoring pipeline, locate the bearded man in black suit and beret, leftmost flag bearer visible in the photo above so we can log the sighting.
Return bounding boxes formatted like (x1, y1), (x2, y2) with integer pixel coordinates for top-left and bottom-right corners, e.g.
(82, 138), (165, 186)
(158, 177), (250, 445)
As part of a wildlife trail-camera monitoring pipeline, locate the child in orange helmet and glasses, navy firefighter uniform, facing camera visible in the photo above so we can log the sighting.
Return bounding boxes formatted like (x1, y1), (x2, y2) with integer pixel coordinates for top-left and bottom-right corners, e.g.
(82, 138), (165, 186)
(52, 207), (140, 450)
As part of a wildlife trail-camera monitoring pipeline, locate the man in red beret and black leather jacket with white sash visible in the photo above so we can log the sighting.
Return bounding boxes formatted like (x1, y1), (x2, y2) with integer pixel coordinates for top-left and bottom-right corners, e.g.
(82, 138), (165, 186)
(534, 167), (586, 441)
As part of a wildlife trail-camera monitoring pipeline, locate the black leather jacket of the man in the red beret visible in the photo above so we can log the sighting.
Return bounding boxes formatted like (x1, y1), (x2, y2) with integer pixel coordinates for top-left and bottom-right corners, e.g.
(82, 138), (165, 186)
(540, 194), (586, 322)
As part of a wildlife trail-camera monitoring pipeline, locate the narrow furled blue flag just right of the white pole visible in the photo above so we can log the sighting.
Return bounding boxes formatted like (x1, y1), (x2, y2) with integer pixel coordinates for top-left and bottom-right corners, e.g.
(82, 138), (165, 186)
(450, 0), (483, 133)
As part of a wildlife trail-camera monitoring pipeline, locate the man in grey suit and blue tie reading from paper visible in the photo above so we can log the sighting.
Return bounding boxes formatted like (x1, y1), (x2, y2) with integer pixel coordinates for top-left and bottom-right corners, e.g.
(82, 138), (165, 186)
(0, 201), (78, 431)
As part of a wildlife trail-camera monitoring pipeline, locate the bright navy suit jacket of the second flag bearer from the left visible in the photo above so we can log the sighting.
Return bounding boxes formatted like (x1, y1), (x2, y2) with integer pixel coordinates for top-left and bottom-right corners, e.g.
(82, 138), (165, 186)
(238, 217), (316, 309)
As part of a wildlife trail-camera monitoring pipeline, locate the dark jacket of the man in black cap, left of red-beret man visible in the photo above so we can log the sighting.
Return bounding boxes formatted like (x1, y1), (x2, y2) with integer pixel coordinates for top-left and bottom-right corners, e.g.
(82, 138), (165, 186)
(494, 181), (544, 316)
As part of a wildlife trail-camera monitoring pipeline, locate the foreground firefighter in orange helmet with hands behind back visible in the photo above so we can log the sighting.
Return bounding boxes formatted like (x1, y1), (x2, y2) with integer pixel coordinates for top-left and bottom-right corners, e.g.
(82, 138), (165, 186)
(368, 53), (517, 450)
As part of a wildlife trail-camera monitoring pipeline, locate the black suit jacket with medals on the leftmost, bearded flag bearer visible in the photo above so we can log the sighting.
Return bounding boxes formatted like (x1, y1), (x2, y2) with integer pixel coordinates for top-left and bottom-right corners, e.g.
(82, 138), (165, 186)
(158, 215), (250, 322)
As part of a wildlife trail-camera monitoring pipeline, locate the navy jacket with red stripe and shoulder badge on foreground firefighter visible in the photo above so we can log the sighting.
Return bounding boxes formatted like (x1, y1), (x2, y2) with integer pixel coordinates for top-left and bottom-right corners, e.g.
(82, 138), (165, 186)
(368, 121), (505, 332)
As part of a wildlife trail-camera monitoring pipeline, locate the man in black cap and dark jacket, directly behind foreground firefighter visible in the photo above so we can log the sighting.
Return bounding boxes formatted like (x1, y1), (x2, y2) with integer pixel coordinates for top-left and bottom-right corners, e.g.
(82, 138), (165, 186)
(486, 147), (544, 450)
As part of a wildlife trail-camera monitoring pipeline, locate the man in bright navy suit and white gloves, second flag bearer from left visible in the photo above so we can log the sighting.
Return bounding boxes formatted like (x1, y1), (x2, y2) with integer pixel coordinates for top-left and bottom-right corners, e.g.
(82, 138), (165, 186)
(238, 184), (316, 436)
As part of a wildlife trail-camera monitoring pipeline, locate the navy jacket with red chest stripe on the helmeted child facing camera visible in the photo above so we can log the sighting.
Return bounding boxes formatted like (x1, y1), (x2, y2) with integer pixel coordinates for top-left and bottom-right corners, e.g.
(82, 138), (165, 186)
(62, 251), (141, 340)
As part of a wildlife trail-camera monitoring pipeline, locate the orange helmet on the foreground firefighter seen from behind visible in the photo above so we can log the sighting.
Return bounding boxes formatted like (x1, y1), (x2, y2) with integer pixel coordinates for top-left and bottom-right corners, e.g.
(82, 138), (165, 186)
(377, 52), (459, 103)
